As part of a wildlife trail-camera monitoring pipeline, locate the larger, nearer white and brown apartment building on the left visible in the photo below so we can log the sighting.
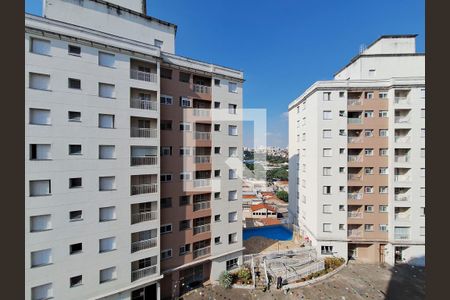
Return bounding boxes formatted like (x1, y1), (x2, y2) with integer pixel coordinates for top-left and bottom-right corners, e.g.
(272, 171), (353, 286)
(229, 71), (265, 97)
(25, 0), (243, 300)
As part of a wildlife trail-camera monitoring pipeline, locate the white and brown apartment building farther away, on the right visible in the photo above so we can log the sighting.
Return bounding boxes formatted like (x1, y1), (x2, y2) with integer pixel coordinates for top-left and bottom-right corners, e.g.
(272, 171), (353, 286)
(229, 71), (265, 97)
(289, 35), (425, 265)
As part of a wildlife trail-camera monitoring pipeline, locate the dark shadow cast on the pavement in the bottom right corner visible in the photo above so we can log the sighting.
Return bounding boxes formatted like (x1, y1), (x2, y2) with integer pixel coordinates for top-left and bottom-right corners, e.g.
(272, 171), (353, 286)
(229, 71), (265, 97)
(385, 256), (425, 300)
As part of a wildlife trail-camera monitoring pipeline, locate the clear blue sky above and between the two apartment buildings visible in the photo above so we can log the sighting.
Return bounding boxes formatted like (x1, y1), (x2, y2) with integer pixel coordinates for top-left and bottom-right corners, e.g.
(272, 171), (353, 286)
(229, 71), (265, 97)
(25, 0), (425, 147)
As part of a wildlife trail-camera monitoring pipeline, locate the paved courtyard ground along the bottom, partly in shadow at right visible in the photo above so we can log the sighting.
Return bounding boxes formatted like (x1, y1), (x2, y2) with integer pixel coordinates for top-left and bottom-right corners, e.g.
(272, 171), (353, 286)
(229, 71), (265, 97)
(184, 262), (425, 300)
